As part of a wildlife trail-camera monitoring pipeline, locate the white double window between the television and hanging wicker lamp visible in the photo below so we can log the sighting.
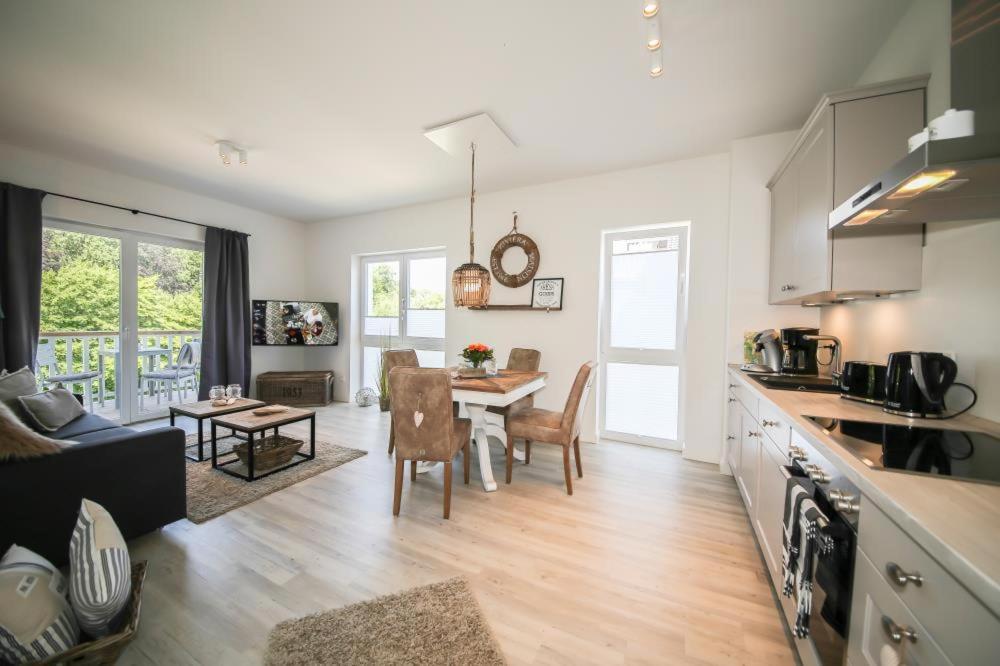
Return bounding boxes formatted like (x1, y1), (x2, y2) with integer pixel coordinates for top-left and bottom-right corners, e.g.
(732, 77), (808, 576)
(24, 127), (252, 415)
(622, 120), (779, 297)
(361, 250), (448, 388)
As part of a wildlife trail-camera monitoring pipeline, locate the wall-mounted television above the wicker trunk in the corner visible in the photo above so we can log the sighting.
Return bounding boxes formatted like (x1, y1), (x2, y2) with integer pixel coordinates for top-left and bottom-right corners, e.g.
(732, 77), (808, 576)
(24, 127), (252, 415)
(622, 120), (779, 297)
(252, 301), (340, 346)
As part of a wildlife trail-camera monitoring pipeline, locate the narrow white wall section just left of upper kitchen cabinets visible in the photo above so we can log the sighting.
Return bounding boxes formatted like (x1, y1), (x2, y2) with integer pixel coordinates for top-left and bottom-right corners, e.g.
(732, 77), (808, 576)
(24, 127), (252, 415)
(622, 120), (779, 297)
(726, 131), (819, 363)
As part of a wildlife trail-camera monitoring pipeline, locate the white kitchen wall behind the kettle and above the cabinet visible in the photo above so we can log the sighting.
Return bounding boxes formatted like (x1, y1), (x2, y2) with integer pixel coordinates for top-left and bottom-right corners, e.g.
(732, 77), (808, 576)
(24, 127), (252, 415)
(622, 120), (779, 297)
(822, 0), (1000, 420)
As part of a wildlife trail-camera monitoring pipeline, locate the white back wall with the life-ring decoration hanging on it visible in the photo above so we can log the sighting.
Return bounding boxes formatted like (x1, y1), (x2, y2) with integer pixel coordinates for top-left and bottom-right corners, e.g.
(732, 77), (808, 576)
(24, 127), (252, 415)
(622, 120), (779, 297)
(306, 155), (729, 462)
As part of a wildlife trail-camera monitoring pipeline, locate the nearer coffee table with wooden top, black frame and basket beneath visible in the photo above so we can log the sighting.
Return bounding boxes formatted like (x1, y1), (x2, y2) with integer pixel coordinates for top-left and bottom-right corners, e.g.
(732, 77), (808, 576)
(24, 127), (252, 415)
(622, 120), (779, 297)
(212, 407), (316, 481)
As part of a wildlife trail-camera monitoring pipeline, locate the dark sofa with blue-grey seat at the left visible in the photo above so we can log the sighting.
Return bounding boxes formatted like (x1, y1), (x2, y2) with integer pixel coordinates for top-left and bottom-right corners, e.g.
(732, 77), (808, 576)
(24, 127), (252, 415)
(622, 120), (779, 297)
(0, 414), (187, 566)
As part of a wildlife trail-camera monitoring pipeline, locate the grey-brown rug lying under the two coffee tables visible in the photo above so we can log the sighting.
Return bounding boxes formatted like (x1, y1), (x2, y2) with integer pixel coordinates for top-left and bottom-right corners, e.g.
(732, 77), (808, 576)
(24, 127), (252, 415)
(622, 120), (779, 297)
(187, 435), (367, 523)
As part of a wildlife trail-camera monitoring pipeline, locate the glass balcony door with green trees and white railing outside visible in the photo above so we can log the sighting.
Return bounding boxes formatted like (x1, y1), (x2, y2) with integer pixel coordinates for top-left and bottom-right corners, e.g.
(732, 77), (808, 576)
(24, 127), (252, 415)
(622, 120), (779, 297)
(37, 220), (203, 423)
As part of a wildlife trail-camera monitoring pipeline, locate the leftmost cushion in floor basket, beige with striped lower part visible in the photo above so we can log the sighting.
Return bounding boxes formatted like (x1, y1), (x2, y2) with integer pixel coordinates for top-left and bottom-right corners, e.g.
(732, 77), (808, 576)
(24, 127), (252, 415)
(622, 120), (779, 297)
(0, 544), (80, 664)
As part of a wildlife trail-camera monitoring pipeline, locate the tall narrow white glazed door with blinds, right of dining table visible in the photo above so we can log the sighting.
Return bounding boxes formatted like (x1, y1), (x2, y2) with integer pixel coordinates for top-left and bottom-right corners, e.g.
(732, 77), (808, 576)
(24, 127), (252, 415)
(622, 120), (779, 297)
(599, 225), (687, 450)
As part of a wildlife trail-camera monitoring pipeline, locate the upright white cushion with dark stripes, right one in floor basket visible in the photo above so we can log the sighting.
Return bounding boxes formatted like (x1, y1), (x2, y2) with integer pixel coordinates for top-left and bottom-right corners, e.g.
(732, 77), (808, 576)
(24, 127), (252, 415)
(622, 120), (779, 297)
(69, 499), (132, 638)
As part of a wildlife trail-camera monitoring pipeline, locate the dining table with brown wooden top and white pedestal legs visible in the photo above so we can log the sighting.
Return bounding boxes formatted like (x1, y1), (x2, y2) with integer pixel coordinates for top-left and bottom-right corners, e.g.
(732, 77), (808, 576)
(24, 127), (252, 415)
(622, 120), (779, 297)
(451, 370), (548, 492)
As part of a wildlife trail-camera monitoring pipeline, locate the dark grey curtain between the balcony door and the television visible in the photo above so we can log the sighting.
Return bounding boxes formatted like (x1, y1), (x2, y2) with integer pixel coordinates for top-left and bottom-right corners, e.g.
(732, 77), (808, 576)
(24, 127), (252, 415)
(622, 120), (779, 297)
(198, 227), (250, 400)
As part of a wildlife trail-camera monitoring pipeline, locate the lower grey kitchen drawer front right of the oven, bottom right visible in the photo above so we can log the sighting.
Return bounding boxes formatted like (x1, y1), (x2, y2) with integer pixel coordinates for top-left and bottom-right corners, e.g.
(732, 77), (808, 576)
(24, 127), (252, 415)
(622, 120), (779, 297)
(847, 548), (948, 666)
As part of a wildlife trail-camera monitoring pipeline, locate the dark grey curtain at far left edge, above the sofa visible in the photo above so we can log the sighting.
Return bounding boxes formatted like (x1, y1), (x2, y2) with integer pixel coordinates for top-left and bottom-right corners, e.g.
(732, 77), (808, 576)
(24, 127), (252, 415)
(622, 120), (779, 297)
(0, 183), (45, 371)
